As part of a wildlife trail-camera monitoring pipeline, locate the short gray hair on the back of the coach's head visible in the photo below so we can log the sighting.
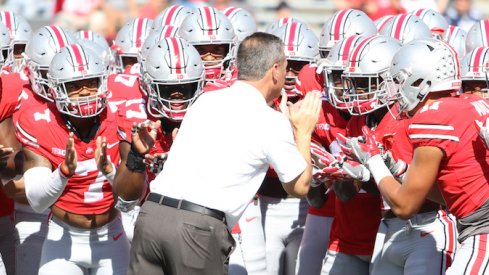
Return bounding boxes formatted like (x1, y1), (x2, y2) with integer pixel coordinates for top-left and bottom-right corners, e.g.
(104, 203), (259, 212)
(236, 32), (285, 80)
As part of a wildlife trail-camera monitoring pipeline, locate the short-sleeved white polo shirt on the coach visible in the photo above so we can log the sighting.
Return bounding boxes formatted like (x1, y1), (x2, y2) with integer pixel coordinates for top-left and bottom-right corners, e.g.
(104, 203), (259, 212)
(150, 81), (307, 227)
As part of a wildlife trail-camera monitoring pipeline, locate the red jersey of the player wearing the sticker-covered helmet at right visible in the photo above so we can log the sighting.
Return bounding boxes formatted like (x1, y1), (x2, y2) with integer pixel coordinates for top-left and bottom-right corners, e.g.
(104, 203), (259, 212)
(408, 94), (489, 218)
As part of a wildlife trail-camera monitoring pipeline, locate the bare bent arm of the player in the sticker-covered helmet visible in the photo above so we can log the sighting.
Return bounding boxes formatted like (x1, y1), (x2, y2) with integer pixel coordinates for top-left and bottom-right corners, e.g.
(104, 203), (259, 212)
(370, 146), (444, 219)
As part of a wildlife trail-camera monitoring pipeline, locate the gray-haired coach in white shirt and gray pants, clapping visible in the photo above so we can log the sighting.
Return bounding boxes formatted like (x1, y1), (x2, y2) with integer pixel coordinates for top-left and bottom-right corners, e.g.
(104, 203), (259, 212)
(128, 33), (321, 275)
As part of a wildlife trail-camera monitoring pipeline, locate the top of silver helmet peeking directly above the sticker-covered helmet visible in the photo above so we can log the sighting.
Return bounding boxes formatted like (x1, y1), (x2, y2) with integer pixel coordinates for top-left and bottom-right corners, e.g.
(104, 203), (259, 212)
(379, 14), (431, 44)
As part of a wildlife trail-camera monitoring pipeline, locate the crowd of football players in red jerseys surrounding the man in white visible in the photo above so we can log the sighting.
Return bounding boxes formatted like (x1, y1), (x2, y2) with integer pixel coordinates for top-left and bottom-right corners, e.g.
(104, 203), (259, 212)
(0, 5), (489, 275)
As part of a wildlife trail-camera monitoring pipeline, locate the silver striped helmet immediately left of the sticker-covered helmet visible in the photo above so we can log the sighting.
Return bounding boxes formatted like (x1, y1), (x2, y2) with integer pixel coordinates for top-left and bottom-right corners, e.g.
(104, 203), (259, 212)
(342, 35), (402, 115)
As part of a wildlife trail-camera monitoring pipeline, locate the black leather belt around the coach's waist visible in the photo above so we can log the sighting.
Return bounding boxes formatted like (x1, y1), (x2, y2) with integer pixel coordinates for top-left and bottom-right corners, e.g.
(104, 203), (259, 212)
(146, 193), (226, 223)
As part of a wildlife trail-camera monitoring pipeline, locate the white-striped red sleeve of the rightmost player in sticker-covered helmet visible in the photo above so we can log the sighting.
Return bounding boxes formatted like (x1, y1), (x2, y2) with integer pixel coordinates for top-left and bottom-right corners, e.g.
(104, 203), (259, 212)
(407, 101), (464, 156)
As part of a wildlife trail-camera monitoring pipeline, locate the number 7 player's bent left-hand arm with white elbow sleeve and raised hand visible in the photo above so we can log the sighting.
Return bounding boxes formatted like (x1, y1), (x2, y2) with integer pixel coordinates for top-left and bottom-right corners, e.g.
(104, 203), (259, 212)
(23, 134), (77, 213)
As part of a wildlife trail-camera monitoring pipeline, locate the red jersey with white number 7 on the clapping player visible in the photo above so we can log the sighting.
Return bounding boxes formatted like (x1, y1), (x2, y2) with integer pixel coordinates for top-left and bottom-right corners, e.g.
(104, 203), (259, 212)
(17, 106), (119, 214)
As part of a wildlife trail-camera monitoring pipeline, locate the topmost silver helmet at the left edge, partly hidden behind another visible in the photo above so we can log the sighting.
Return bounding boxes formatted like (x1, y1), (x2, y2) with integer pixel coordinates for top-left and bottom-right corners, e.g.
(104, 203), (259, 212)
(0, 11), (32, 71)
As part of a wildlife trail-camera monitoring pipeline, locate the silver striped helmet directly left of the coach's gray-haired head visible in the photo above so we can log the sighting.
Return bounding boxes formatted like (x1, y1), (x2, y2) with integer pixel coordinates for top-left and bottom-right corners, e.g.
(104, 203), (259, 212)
(178, 7), (237, 80)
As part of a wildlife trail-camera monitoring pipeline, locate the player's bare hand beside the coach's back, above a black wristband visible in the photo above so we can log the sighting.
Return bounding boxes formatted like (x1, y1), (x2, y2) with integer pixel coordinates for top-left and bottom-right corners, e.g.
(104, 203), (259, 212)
(131, 120), (161, 155)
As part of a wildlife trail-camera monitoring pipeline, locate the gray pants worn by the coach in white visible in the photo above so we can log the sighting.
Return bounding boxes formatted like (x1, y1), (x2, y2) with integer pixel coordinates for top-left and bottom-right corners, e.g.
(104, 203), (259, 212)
(128, 201), (234, 275)
